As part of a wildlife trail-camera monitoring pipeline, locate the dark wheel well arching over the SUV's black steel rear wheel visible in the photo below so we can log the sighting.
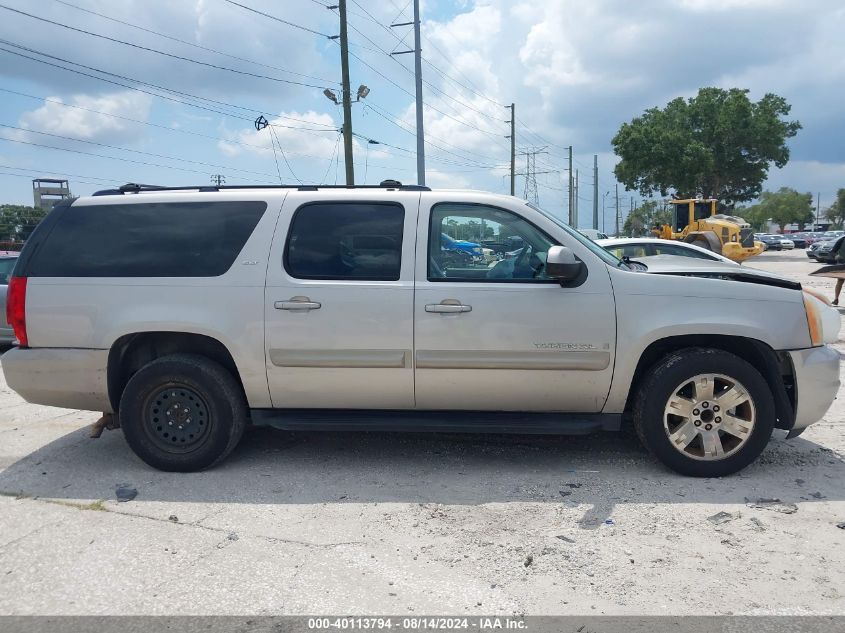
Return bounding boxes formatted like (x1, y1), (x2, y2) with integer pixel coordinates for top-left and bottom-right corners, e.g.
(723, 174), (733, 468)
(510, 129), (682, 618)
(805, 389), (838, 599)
(107, 332), (243, 411)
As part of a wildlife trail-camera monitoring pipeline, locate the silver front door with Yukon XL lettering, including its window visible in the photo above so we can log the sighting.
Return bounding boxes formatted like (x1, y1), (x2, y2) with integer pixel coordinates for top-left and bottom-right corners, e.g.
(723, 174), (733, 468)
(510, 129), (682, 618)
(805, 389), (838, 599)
(414, 200), (616, 412)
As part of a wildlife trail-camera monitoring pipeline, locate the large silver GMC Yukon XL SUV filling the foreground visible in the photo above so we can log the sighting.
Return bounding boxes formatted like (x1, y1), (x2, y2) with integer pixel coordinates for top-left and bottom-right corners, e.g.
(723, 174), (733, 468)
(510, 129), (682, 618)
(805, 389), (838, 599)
(2, 181), (839, 477)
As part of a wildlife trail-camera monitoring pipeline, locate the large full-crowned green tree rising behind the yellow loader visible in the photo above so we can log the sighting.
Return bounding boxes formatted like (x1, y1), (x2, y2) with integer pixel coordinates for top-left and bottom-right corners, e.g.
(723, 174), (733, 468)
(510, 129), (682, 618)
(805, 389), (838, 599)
(612, 88), (801, 203)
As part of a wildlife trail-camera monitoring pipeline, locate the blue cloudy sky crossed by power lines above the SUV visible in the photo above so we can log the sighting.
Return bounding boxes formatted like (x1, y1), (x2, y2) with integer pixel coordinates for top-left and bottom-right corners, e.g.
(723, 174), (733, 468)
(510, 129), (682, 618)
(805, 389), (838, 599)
(0, 0), (845, 229)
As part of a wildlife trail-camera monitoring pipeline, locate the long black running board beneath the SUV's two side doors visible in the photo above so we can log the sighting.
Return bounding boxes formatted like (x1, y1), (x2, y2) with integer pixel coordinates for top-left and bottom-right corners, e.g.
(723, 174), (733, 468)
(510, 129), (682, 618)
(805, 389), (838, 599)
(250, 409), (622, 435)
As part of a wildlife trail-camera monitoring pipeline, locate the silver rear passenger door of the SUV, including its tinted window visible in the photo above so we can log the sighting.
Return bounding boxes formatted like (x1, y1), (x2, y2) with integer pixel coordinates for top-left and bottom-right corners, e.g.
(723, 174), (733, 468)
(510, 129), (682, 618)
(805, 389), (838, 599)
(265, 189), (420, 409)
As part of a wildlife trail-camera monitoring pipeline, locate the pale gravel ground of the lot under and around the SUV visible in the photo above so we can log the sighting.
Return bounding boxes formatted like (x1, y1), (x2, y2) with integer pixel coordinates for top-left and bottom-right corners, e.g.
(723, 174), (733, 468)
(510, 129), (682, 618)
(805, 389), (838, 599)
(0, 251), (845, 615)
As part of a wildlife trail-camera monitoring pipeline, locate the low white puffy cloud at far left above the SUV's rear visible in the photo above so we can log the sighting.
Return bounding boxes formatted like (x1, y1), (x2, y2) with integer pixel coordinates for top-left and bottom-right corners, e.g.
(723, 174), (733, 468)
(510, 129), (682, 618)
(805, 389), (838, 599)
(15, 91), (152, 143)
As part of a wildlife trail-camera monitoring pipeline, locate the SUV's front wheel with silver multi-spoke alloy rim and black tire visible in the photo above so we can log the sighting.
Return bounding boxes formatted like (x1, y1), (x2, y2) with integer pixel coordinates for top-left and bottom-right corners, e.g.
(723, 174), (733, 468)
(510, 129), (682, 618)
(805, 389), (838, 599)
(634, 348), (775, 477)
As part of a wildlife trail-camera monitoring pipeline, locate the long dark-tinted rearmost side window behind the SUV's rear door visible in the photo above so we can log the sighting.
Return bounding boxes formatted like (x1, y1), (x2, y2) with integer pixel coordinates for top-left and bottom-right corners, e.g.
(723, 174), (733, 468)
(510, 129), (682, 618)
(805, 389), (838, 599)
(27, 201), (267, 277)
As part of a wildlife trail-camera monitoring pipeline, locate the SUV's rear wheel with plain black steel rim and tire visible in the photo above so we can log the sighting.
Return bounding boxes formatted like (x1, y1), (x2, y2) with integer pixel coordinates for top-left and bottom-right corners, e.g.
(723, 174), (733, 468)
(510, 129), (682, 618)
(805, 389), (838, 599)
(120, 354), (247, 472)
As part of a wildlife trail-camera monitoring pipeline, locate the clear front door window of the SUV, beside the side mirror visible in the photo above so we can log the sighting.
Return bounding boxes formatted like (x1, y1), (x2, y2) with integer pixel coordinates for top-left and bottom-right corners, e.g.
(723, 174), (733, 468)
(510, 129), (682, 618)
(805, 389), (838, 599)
(428, 203), (555, 282)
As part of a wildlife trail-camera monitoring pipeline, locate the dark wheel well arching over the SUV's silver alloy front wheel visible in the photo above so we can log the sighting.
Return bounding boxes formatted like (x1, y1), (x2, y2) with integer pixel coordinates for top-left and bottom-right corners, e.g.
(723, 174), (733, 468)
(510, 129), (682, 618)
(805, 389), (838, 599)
(625, 334), (795, 429)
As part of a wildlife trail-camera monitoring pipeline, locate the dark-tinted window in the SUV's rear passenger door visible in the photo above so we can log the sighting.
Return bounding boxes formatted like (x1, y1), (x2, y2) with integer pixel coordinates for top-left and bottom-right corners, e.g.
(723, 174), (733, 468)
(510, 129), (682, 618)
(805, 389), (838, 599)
(284, 202), (405, 281)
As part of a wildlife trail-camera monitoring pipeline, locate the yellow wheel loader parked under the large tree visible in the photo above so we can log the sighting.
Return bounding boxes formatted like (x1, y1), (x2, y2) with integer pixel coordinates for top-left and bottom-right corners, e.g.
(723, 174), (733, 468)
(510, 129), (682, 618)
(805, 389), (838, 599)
(652, 198), (763, 262)
